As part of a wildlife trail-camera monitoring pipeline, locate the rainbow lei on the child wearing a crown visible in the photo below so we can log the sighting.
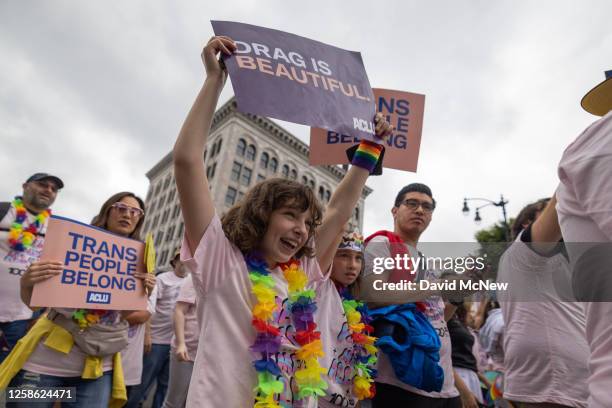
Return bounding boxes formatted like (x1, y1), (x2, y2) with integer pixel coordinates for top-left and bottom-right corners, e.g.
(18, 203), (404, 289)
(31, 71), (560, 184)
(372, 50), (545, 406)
(339, 288), (378, 400)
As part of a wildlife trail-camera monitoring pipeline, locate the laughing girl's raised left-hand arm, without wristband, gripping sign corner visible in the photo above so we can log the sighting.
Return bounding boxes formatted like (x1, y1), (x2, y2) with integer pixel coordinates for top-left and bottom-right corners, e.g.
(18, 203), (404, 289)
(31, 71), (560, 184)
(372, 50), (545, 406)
(173, 37), (236, 253)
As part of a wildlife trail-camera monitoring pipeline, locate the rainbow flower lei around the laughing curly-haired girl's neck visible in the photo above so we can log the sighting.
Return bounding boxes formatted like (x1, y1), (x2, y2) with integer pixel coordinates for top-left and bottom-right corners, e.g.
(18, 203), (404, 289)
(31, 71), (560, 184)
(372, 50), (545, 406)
(245, 254), (327, 408)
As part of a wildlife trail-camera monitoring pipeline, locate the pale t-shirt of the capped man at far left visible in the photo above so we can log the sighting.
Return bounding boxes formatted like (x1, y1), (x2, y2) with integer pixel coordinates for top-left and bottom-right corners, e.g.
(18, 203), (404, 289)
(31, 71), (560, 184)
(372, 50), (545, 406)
(0, 205), (47, 322)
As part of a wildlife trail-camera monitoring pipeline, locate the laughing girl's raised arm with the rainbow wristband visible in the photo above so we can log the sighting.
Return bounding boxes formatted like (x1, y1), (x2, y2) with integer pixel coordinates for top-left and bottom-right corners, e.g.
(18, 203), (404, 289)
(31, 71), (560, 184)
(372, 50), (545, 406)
(315, 113), (393, 271)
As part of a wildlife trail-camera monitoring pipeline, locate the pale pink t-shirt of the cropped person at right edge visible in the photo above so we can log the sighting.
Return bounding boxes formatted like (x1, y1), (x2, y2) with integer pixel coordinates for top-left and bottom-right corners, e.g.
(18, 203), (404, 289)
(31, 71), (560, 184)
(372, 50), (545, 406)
(557, 111), (612, 408)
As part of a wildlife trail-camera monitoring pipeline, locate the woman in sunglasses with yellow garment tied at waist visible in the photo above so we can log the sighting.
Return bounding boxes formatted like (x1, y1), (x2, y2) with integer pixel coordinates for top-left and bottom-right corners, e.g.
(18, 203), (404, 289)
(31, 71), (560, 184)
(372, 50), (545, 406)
(0, 192), (155, 408)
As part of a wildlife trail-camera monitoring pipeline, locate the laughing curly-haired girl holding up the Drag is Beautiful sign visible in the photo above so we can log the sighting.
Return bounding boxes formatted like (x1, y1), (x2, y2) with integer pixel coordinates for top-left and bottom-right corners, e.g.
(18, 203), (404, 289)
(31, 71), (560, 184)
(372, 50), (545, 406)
(173, 36), (392, 408)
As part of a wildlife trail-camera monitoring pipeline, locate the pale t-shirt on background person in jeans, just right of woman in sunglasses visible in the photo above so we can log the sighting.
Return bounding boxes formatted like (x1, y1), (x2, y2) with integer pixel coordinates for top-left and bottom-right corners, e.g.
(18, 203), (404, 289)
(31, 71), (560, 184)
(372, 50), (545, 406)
(151, 271), (185, 344)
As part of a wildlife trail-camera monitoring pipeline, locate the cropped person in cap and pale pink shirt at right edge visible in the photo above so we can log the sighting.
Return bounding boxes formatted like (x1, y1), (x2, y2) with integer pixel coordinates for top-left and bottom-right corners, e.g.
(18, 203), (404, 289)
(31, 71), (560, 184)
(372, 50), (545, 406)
(557, 70), (612, 408)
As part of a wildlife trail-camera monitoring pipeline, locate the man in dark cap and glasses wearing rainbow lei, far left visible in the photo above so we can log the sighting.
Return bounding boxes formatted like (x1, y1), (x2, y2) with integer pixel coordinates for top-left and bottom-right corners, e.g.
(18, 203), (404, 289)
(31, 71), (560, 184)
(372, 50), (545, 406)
(0, 173), (64, 363)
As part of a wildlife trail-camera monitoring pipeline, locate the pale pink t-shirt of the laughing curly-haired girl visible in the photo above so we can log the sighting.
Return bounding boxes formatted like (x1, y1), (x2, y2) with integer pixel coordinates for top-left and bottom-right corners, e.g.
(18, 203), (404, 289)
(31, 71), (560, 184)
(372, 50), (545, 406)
(181, 215), (323, 408)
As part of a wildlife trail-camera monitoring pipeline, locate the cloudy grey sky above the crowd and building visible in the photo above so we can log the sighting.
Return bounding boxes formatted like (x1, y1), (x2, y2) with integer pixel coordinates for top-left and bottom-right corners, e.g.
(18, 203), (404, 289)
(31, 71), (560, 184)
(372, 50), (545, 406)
(0, 0), (612, 241)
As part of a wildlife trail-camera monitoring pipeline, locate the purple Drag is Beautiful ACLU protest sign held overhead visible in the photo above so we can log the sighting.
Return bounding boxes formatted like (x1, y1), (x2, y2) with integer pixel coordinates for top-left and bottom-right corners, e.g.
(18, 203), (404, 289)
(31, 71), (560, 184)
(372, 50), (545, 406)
(211, 21), (375, 139)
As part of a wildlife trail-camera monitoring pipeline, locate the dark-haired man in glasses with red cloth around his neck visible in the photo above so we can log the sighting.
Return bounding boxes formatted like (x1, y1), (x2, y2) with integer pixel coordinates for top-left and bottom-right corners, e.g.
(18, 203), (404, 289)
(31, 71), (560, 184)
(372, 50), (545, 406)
(360, 183), (466, 408)
